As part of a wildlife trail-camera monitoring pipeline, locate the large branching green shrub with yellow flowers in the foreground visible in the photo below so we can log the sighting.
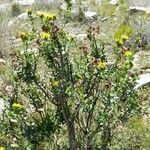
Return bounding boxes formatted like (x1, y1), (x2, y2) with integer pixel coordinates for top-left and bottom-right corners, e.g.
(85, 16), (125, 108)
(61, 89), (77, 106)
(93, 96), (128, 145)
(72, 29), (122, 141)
(0, 10), (141, 150)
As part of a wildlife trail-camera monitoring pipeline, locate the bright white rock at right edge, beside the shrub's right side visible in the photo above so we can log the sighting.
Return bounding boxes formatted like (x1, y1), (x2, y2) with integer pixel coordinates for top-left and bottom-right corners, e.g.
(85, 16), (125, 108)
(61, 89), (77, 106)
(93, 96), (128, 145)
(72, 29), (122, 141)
(135, 73), (150, 89)
